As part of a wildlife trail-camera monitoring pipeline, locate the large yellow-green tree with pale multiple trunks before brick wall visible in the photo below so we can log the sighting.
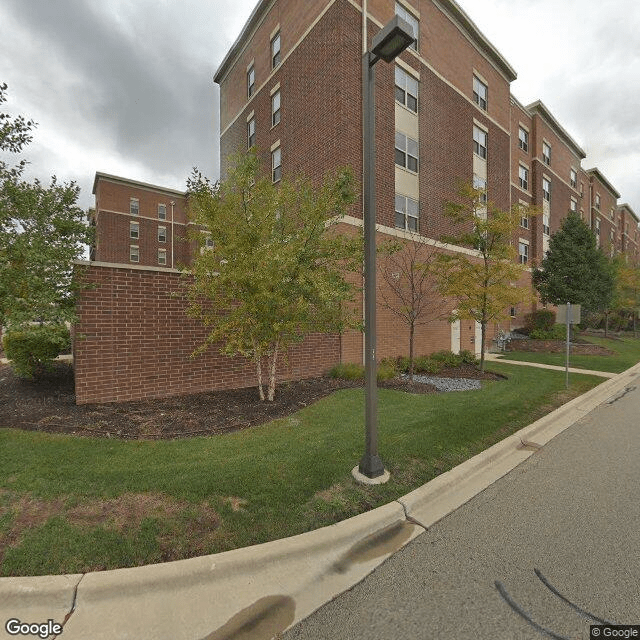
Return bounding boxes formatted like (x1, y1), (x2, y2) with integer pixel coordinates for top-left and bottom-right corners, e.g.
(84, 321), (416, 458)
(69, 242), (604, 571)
(188, 151), (362, 401)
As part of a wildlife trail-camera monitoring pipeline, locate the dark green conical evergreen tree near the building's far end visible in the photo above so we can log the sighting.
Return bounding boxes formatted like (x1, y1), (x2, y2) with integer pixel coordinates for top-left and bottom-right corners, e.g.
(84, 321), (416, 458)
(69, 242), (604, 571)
(533, 212), (614, 311)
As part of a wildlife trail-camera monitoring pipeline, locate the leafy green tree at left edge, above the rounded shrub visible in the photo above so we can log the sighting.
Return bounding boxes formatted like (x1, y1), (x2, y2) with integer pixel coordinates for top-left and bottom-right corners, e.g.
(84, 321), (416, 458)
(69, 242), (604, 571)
(0, 84), (91, 326)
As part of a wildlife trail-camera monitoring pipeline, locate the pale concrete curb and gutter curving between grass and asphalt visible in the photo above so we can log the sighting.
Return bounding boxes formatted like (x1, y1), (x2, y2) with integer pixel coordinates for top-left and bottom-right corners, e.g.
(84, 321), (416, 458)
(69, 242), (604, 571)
(0, 364), (640, 640)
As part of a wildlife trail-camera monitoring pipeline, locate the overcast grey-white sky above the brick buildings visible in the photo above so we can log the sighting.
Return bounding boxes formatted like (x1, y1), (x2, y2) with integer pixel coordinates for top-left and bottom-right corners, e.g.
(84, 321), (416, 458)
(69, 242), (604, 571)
(0, 0), (640, 214)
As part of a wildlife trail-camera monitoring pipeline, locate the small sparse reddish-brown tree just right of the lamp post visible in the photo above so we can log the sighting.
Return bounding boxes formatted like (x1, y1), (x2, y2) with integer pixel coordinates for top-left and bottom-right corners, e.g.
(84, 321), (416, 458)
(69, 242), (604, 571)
(379, 234), (443, 382)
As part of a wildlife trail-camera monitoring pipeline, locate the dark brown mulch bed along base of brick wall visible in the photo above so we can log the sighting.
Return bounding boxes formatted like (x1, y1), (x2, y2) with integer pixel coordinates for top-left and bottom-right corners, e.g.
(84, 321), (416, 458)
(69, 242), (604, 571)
(0, 363), (500, 440)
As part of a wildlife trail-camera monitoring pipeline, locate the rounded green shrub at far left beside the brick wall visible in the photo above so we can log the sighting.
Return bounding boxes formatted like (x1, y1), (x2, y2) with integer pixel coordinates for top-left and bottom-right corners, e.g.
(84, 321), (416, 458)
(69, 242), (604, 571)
(2, 325), (71, 379)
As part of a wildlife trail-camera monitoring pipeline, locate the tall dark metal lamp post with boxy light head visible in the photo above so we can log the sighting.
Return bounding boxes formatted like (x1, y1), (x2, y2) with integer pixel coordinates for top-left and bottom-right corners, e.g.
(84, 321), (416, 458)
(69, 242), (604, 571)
(354, 16), (415, 482)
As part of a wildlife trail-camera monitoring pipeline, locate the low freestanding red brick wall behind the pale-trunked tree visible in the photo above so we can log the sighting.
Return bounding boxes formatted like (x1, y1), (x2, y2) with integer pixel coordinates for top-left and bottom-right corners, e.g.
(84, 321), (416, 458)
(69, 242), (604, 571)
(74, 265), (340, 404)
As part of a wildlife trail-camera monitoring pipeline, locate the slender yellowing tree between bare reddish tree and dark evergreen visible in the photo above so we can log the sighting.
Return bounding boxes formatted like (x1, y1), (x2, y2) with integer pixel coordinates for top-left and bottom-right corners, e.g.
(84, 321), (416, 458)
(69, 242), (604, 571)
(438, 184), (536, 371)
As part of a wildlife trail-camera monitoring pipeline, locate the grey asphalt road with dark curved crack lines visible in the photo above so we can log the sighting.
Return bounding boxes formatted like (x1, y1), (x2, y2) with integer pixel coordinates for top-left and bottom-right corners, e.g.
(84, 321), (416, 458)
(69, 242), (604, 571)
(283, 379), (640, 640)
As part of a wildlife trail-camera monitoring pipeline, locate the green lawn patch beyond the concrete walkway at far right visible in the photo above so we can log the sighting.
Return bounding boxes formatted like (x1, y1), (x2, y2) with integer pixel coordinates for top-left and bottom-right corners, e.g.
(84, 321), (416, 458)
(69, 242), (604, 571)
(504, 336), (640, 373)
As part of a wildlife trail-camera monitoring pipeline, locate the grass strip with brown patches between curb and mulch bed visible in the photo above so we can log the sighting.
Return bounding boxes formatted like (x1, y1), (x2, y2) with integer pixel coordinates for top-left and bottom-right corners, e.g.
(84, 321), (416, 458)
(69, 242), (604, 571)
(0, 363), (602, 575)
